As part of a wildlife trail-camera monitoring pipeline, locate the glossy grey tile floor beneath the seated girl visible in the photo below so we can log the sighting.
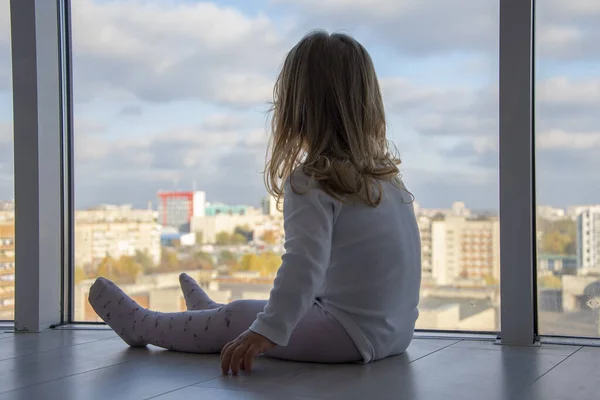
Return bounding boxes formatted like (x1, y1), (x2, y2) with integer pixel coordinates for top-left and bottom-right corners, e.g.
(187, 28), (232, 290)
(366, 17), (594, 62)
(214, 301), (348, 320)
(0, 329), (600, 400)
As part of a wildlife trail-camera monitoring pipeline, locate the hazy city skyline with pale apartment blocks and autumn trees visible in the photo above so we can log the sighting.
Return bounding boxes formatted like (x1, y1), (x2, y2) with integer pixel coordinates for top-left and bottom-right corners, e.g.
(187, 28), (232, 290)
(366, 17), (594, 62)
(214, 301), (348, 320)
(0, 185), (600, 335)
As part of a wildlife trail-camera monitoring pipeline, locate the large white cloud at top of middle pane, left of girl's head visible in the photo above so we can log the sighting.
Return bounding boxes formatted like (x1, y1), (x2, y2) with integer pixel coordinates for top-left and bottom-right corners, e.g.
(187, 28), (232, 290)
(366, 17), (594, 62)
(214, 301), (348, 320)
(73, 0), (287, 106)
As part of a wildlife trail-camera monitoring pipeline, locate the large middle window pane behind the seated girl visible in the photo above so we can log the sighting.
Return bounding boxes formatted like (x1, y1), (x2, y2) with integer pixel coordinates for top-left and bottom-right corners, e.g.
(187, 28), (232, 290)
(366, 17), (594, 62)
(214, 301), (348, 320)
(73, 0), (499, 331)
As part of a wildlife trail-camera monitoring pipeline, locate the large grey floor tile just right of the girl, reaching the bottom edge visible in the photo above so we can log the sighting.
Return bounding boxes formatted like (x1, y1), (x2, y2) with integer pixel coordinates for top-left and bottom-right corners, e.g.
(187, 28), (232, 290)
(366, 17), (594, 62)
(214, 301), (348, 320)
(327, 346), (565, 400)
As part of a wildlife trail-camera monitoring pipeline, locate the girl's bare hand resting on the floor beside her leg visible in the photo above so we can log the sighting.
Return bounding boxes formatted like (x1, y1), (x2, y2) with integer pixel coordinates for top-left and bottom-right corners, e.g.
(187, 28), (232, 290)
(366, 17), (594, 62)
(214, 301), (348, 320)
(221, 331), (277, 375)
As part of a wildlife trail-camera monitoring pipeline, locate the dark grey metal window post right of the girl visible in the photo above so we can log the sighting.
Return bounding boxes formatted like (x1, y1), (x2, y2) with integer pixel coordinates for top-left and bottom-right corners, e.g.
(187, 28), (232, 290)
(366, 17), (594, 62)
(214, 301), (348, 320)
(499, 0), (537, 346)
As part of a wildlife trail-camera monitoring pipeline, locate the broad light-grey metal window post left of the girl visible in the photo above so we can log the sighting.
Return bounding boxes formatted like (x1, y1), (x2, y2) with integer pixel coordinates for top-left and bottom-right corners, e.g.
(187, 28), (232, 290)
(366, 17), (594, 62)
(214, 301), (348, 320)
(10, 0), (65, 332)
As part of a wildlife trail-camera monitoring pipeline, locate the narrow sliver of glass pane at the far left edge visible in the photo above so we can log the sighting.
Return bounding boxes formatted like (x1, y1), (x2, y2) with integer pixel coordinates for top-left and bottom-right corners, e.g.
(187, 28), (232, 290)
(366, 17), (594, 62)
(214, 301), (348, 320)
(0, 0), (15, 320)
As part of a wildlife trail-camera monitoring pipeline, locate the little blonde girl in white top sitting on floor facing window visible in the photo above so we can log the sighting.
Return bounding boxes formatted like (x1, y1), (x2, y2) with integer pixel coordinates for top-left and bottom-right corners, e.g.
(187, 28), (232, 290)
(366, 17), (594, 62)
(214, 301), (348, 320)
(89, 31), (421, 375)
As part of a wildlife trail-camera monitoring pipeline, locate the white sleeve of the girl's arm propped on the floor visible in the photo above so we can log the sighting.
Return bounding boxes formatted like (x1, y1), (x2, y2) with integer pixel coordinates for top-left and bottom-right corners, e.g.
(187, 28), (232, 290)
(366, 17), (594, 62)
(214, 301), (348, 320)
(250, 177), (334, 346)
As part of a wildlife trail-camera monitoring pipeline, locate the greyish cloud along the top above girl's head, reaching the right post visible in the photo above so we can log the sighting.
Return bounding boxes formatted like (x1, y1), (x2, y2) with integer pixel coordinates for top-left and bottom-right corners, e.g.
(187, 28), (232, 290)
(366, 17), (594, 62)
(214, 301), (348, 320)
(278, 0), (498, 55)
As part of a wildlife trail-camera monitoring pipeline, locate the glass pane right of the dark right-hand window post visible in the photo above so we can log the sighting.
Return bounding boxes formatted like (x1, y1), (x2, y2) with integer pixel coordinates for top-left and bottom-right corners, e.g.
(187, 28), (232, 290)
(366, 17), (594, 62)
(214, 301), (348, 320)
(536, 0), (600, 337)
